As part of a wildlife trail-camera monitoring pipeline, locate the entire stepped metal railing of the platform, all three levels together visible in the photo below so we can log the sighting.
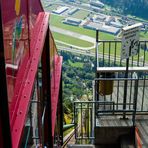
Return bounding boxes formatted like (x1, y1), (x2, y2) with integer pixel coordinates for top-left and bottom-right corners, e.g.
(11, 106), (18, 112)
(74, 31), (148, 144)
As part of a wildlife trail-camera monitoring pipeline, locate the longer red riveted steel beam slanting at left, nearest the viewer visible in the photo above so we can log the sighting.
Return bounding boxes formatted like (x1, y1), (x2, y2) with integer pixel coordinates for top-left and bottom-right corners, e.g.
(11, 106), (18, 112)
(11, 12), (49, 148)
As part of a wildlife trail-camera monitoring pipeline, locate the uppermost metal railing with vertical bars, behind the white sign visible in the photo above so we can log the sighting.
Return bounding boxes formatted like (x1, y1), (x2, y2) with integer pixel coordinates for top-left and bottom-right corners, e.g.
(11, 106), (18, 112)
(96, 40), (148, 67)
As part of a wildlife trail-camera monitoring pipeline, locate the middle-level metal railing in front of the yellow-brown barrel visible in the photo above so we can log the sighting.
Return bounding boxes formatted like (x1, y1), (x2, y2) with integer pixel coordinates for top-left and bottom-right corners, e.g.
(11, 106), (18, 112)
(95, 73), (148, 114)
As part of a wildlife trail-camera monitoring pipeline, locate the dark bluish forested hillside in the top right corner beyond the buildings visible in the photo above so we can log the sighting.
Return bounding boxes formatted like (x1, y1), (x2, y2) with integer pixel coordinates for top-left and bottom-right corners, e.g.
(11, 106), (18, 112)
(100, 0), (148, 19)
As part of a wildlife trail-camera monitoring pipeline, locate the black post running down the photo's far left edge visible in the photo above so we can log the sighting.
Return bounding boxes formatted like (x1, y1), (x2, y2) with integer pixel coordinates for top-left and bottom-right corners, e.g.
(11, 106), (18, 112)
(0, 1), (12, 148)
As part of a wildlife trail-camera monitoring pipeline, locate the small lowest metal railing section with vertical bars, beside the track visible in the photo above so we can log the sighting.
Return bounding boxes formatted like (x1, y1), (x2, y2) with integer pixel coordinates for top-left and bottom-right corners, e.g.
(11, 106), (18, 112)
(74, 101), (95, 144)
